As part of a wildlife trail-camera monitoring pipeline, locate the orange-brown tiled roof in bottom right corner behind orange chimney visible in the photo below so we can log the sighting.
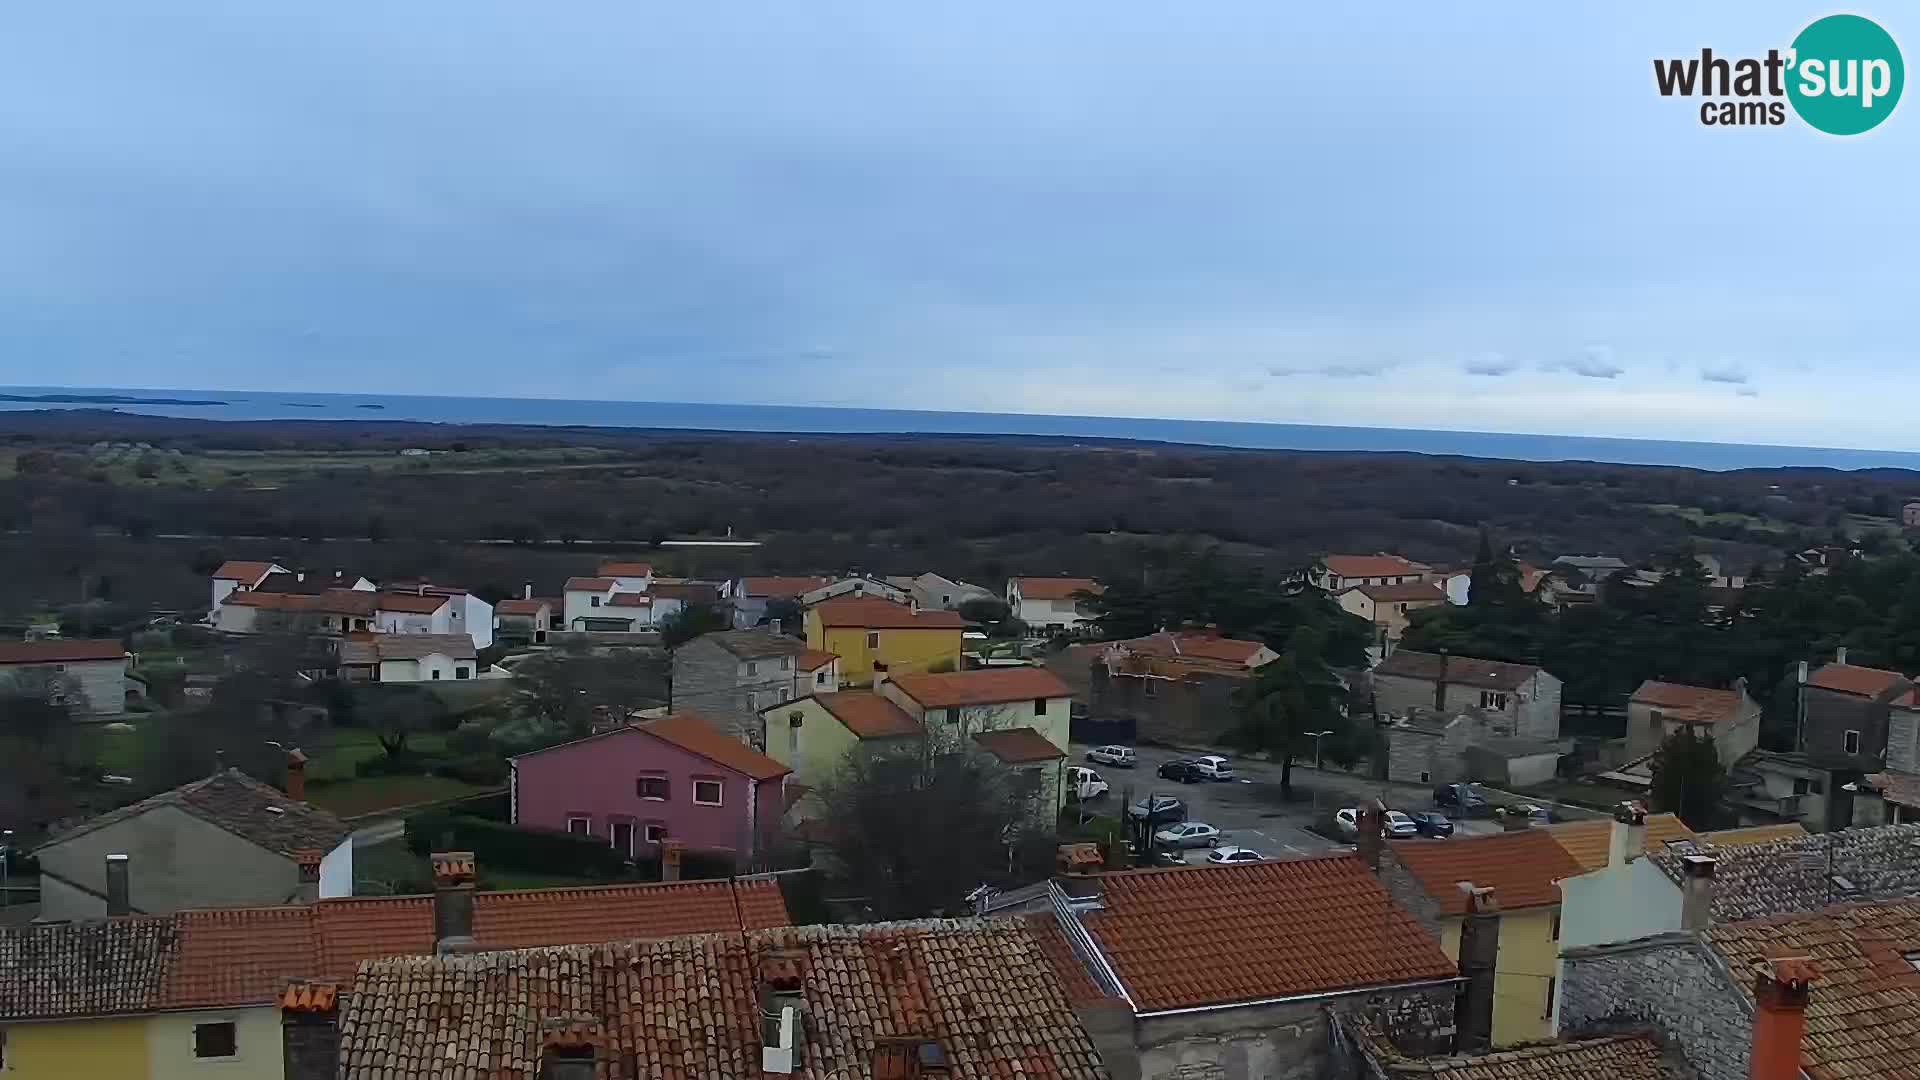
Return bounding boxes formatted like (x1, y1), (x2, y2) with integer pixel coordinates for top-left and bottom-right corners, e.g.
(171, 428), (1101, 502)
(1707, 899), (1920, 1080)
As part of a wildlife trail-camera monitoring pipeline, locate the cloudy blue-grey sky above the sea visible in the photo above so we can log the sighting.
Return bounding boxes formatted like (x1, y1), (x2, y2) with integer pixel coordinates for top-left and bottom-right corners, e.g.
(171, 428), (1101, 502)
(0, 0), (1920, 450)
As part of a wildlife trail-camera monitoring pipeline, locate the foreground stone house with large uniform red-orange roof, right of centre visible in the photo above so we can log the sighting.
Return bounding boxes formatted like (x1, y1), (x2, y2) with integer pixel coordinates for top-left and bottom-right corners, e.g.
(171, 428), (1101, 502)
(1027, 853), (1463, 1080)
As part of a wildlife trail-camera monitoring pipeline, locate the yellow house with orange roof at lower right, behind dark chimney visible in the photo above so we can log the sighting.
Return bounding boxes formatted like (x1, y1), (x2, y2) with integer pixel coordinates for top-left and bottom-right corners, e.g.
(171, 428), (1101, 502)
(1380, 828), (1580, 1047)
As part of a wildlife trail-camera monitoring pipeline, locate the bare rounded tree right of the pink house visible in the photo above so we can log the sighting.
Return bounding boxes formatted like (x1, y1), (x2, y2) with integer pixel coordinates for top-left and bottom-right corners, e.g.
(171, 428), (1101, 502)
(816, 734), (1041, 919)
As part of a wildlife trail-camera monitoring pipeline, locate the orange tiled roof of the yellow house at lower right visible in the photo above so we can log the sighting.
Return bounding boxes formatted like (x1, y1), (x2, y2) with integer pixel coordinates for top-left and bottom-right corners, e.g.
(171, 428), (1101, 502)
(1390, 828), (1584, 915)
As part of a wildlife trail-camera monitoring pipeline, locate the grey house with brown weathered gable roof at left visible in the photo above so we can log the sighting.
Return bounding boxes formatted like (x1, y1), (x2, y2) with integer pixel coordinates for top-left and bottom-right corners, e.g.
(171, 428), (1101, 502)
(35, 751), (353, 919)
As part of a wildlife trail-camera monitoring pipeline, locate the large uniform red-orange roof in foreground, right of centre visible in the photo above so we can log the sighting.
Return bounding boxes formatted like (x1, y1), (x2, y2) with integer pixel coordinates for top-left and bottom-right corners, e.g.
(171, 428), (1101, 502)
(1077, 842), (1457, 1013)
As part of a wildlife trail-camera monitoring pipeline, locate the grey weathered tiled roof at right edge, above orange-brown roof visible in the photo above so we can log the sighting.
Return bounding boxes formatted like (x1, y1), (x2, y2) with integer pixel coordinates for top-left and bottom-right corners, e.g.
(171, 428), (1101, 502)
(1651, 824), (1920, 922)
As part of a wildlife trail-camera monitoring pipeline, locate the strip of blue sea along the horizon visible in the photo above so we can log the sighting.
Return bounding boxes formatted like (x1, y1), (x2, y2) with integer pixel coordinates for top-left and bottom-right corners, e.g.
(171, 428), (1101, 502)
(0, 386), (1920, 471)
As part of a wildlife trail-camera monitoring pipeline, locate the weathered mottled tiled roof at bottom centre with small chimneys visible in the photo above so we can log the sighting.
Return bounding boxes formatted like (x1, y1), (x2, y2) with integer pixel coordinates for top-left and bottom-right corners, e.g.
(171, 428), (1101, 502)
(340, 920), (1106, 1080)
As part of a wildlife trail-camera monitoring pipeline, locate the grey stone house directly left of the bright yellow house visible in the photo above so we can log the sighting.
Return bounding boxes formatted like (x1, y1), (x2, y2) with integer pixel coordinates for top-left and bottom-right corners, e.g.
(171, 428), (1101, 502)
(670, 626), (814, 748)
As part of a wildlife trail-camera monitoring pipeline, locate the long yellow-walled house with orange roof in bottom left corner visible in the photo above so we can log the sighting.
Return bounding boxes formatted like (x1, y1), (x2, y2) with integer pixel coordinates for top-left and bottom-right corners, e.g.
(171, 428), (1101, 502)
(0, 857), (789, 1080)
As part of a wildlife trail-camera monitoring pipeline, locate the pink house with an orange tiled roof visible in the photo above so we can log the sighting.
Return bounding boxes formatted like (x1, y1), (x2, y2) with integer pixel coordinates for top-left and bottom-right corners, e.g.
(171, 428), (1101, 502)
(511, 713), (791, 869)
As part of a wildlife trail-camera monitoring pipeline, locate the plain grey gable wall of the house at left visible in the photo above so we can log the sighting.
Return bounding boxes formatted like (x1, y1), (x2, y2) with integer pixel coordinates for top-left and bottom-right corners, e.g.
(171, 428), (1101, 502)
(40, 807), (300, 919)
